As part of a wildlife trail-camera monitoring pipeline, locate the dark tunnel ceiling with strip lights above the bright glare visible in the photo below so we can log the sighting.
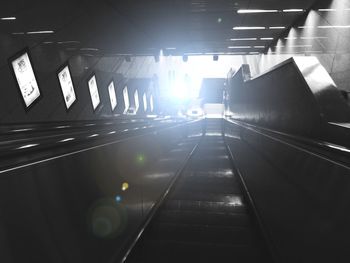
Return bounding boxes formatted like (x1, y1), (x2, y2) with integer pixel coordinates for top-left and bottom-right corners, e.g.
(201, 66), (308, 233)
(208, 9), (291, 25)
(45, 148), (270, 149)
(0, 0), (328, 55)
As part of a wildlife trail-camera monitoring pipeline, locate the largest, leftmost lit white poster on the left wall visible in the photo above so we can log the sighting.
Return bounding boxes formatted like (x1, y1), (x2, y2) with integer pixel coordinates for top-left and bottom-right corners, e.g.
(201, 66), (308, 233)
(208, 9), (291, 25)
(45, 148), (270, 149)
(12, 53), (40, 107)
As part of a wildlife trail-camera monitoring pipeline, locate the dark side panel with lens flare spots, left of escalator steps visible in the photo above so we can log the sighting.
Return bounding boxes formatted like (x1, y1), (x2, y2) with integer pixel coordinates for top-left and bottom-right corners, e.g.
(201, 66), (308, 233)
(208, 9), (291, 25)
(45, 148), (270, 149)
(0, 122), (201, 263)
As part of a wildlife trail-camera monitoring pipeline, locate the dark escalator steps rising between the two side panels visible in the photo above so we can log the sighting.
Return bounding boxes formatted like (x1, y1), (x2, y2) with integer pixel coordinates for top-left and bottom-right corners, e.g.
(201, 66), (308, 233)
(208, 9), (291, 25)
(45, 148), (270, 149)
(126, 123), (273, 263)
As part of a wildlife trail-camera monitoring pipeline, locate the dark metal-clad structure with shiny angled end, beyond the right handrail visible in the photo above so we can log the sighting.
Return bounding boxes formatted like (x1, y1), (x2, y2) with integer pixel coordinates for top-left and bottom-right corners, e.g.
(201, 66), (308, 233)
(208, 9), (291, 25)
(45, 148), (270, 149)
(228, 57), (350, 146)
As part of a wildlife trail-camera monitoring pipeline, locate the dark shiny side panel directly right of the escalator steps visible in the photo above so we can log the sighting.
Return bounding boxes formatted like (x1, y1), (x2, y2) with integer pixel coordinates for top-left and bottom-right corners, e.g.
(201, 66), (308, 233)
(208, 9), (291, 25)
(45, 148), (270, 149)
(225, 121), (350, 263)
